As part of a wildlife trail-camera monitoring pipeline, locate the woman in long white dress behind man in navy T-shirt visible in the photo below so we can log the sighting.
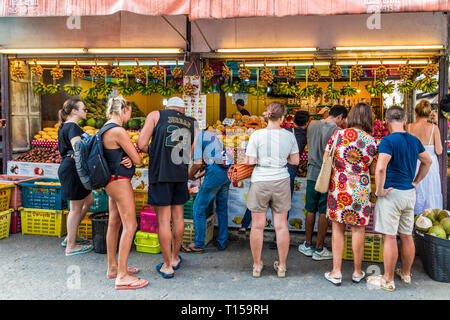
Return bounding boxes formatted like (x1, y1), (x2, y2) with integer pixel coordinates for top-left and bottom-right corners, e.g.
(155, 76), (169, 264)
(407, 100), (443, 215)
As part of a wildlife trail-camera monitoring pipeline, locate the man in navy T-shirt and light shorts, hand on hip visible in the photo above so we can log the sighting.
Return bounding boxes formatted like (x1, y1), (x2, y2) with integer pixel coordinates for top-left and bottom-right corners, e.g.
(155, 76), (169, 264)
(367, 106), (431, 291)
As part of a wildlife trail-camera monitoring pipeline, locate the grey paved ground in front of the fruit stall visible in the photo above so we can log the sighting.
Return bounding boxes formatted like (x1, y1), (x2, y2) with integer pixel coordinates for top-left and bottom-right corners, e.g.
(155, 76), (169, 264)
(0, 233), (450, 300)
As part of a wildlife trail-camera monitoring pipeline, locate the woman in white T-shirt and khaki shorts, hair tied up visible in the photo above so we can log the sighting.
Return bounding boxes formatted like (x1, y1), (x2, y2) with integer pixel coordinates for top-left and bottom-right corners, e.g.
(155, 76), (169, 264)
(245, 102), (300, 278)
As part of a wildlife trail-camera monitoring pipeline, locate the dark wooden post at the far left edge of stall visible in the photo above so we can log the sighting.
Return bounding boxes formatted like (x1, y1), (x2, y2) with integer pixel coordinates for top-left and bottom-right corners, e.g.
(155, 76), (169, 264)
(0, 54), (11, 174)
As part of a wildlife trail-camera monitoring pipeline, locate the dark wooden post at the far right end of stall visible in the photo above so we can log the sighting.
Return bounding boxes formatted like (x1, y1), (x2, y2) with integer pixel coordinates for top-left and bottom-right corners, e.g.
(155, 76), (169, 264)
(438, 55), (448, 209)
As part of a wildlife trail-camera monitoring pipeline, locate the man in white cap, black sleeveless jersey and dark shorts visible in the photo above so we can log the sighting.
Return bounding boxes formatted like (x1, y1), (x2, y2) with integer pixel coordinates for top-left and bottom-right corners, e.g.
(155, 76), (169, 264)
(137, 97), (197, 278)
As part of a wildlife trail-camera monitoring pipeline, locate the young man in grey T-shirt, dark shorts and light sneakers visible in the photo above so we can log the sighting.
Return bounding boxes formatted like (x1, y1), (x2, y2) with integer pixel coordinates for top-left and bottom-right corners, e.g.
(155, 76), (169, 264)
(298, 105), (348, 260)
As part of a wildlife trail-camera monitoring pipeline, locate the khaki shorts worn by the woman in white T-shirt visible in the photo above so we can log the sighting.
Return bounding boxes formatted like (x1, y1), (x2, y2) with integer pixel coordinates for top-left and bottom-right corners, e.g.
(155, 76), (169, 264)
(247, 178), (291, 213)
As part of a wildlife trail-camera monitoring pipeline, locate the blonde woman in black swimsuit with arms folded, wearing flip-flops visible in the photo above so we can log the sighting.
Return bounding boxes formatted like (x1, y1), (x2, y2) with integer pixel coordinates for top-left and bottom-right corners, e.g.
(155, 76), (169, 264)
(102, 96), (148, 290)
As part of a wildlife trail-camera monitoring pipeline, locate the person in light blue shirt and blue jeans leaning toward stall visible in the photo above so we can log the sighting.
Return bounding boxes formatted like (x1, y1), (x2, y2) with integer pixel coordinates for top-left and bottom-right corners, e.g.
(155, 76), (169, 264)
(182, 130), (230, 253)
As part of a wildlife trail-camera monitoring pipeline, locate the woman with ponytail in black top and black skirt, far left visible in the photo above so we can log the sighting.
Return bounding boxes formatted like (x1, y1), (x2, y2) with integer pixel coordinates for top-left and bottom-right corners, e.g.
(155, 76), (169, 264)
(58, 99), (94, 256)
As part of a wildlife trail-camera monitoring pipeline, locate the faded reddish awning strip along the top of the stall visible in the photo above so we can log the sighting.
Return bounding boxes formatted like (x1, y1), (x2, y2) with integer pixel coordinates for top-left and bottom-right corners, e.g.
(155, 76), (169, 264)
(0, 0), (450, 20)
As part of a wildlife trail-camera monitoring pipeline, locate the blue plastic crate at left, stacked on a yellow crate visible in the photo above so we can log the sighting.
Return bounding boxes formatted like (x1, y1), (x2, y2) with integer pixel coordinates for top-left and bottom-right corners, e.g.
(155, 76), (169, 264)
(19, 178), (67, 210)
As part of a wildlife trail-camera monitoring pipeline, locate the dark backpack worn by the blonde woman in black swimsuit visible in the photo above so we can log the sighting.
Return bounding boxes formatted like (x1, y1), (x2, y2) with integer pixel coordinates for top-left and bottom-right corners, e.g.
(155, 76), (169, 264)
(74, 123), (119, 190)
